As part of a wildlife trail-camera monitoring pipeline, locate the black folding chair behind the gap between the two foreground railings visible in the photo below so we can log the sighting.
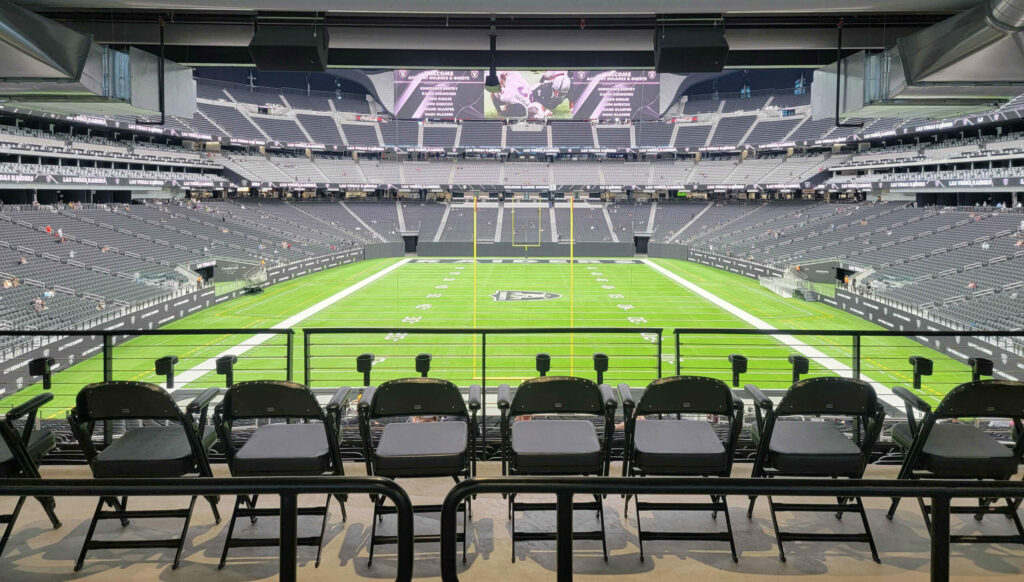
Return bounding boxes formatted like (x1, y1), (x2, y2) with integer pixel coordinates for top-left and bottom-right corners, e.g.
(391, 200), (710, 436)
(359, 377), (480, 565)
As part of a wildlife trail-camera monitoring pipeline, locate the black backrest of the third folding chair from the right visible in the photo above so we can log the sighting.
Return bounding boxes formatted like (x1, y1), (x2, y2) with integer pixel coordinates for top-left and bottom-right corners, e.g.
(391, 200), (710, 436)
(636, 376), (733, 415)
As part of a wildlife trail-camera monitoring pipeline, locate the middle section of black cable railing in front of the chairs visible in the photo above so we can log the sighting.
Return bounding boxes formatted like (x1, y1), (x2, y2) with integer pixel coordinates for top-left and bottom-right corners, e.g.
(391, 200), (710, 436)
(302, 327), (663, 450)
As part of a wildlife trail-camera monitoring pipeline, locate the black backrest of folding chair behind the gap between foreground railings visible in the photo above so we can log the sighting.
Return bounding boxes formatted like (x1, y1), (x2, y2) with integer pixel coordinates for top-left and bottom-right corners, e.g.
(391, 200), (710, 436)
(370, 378), (469, 418)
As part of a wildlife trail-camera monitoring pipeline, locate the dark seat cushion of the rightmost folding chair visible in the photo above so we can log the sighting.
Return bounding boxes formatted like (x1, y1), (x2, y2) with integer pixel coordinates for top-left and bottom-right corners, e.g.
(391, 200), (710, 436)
(893, 422), (1017, 479)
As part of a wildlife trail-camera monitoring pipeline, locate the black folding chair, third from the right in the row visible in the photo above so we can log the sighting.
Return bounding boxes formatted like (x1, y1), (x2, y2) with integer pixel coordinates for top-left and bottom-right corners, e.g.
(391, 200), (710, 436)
(618, 376), (743, 562)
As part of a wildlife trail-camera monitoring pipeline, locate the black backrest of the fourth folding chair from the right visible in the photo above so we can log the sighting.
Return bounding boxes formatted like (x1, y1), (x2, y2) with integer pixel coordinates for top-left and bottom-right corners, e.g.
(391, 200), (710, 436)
(509, 376), (604, 416)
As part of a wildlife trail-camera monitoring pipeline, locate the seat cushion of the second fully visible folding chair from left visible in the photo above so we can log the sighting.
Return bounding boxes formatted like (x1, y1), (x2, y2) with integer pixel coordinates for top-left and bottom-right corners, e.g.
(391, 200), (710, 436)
(232, 422), (331, 476)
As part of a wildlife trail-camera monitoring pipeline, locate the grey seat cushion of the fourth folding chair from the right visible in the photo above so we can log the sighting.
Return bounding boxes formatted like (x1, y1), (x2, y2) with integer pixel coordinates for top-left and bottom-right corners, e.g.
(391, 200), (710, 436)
(512, 420), (602, 474)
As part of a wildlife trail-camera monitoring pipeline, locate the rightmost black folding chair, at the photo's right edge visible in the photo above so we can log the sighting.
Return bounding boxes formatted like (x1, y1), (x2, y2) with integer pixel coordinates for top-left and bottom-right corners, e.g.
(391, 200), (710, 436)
(887, 380), (1024, 543)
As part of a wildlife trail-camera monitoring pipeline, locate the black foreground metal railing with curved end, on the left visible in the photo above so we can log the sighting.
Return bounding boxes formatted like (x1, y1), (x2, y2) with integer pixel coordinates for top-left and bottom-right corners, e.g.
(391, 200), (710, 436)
(0, 476), (413, 582)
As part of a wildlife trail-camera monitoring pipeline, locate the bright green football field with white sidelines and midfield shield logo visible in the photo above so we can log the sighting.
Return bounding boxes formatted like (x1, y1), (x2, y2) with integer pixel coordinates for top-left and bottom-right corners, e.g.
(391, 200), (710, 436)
(0, 258), (970, 418)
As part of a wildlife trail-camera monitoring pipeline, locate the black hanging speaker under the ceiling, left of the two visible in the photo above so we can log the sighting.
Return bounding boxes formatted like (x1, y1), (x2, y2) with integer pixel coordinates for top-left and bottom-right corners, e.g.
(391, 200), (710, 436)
(249, 25), (329, 73)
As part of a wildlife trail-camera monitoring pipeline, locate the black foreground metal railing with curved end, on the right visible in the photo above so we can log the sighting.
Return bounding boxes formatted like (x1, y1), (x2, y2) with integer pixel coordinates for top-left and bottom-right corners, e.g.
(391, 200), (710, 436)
(440, 476), (1024, 582)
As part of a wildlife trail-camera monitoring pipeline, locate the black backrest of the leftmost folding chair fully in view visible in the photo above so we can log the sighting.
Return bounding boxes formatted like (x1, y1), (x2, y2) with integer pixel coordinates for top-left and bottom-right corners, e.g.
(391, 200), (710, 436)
(75, 381), (181, 422)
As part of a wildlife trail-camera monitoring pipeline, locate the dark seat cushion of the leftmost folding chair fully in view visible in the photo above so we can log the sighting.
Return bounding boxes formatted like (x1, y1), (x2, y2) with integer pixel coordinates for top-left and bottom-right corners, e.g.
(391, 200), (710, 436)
(92, 425), (217, 477)
